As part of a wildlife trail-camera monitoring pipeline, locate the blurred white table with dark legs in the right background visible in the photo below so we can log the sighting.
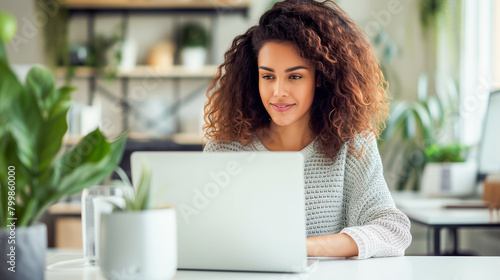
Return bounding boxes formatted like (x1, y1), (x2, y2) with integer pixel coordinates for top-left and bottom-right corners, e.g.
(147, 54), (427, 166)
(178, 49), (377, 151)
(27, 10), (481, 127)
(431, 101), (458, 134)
(392, 192), (500, 256)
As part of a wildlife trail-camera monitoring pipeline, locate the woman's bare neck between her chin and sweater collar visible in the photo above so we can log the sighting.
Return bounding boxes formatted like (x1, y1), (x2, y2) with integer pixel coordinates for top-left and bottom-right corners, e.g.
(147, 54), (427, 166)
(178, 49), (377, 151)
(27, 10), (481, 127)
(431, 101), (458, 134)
(257, 122), (316, 151)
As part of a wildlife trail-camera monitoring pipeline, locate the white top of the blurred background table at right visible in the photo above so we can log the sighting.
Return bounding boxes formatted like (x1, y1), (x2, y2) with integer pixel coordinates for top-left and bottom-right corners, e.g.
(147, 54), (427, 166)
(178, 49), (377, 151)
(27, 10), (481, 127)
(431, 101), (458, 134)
(392, 192), (500, 226)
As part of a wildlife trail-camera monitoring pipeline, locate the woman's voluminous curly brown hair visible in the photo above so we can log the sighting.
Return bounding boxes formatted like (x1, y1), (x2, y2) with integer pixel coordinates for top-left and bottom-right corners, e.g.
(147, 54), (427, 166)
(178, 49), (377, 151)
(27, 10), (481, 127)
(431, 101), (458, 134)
(203, 0), (389, 157)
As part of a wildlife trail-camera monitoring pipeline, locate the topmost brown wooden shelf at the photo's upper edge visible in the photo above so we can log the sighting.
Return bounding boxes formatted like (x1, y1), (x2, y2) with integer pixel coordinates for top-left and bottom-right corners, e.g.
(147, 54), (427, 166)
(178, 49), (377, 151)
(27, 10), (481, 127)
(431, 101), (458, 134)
(66, 0), (250, 9)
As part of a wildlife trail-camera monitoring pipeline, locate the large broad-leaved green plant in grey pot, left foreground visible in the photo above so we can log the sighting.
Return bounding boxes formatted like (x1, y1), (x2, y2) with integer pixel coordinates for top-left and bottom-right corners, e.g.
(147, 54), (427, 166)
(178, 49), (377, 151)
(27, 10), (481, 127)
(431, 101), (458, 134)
(0, 13), (126, 279)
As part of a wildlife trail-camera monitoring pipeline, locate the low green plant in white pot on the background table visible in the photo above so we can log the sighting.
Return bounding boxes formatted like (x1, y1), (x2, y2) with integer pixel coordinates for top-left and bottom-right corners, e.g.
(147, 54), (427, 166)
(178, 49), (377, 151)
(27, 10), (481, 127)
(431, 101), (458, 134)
(420, 143), (477, 197)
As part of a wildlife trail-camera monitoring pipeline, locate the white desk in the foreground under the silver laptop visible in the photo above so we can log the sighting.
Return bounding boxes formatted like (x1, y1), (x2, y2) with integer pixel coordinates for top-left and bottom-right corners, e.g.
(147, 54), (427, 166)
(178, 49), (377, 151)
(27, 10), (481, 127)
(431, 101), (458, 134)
(45, 252), (500, 280)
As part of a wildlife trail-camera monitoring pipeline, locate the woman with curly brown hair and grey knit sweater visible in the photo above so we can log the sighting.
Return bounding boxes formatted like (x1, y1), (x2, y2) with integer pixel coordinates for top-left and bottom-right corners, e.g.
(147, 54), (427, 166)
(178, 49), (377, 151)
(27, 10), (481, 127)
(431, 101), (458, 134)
(204, 0), (411, 259)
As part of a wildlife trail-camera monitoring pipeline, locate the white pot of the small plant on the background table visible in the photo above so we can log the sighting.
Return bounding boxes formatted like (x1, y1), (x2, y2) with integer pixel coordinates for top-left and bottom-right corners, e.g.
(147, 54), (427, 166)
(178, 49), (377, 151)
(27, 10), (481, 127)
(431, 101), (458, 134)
(420, 161), (477, 197)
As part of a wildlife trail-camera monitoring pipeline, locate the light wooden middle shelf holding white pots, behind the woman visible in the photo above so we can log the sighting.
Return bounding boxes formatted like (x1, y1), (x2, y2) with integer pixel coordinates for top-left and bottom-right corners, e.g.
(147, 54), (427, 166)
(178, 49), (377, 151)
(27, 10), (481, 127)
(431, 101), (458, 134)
(56, 65), (218, 79)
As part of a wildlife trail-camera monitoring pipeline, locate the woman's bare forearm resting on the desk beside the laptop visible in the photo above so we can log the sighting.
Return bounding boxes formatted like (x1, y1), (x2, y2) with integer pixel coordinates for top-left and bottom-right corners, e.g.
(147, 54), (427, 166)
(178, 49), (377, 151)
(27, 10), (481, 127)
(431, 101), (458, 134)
(306, 233), (358, 257)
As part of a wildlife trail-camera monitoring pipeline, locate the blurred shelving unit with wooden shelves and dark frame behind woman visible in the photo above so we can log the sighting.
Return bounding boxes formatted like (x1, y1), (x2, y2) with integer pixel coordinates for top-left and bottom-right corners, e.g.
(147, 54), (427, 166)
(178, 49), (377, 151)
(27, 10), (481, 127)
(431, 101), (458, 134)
(56, 0), (250, 184)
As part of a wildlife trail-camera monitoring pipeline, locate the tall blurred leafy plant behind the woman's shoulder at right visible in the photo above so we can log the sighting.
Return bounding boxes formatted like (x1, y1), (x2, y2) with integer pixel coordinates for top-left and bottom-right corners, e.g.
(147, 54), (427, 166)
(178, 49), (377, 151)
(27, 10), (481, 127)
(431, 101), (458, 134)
(380, 74), (458, 191)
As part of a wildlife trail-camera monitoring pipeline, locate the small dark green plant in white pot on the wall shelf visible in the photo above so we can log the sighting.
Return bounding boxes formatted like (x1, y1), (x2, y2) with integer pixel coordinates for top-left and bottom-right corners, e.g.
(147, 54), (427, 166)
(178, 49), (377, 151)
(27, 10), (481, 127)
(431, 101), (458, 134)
(181, 23), (208, 71)
